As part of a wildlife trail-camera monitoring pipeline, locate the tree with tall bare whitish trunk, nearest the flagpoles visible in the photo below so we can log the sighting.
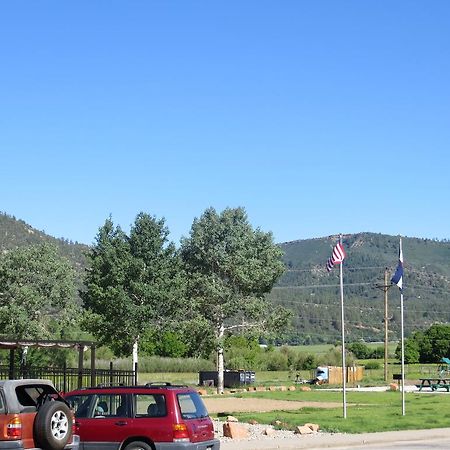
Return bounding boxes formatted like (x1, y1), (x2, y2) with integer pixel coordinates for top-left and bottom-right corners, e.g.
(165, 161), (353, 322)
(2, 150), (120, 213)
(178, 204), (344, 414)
(181, 208), (289, 392)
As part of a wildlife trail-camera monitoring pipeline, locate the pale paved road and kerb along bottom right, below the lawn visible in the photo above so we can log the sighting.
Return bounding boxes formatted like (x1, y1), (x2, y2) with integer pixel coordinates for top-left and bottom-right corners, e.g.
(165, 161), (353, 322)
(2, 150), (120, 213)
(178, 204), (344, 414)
(220, 428), (450, 450)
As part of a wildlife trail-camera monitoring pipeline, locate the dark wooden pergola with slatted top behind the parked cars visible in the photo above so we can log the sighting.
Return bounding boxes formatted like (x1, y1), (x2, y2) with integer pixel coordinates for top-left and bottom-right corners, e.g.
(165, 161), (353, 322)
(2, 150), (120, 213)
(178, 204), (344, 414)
(0, 337), (96, 387)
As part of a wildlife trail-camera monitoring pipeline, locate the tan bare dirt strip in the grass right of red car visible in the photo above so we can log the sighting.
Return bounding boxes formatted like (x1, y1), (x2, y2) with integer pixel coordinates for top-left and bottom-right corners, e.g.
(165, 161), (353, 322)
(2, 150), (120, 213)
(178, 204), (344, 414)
(203, 397), (342, 414)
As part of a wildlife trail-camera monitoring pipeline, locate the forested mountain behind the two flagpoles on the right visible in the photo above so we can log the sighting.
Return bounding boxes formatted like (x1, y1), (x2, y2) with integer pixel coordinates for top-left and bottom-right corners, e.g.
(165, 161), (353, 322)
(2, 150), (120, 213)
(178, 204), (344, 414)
(270, 233), (450, 343)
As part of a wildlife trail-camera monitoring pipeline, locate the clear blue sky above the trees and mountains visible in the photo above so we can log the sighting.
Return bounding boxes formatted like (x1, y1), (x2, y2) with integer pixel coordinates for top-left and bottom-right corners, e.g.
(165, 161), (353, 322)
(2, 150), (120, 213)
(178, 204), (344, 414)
(0, 0), (450, 244)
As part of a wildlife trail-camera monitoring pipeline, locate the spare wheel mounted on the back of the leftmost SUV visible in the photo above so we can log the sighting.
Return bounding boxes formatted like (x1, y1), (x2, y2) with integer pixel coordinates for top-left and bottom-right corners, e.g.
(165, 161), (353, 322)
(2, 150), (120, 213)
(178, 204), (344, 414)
(34, 401), (72, 450)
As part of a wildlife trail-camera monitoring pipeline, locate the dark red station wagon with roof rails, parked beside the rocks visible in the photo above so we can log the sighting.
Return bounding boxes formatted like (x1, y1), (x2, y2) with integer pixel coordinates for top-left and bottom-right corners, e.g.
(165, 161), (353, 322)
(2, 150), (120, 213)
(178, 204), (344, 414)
(65, 383), (220, 450)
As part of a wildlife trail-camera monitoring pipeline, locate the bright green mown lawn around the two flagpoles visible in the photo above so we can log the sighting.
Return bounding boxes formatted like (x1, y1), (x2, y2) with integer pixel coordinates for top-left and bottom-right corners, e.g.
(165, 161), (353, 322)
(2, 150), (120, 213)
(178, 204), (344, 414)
(214, 390), (450, 433)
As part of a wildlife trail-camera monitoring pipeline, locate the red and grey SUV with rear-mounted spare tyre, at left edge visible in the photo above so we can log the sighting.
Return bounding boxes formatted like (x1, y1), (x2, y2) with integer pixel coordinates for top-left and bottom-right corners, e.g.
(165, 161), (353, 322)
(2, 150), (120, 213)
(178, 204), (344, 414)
(0, 380), (79, 450)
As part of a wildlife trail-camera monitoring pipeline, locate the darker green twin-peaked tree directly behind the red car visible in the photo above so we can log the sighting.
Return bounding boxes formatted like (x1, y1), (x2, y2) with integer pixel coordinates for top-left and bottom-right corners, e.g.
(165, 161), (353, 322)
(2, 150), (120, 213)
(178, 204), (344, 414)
(81, 212), (183, 364)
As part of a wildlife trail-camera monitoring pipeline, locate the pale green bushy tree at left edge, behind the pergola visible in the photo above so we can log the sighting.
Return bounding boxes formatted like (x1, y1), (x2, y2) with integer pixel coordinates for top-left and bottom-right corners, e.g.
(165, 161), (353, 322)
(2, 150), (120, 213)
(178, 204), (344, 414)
(0, 244), (79, 339)
